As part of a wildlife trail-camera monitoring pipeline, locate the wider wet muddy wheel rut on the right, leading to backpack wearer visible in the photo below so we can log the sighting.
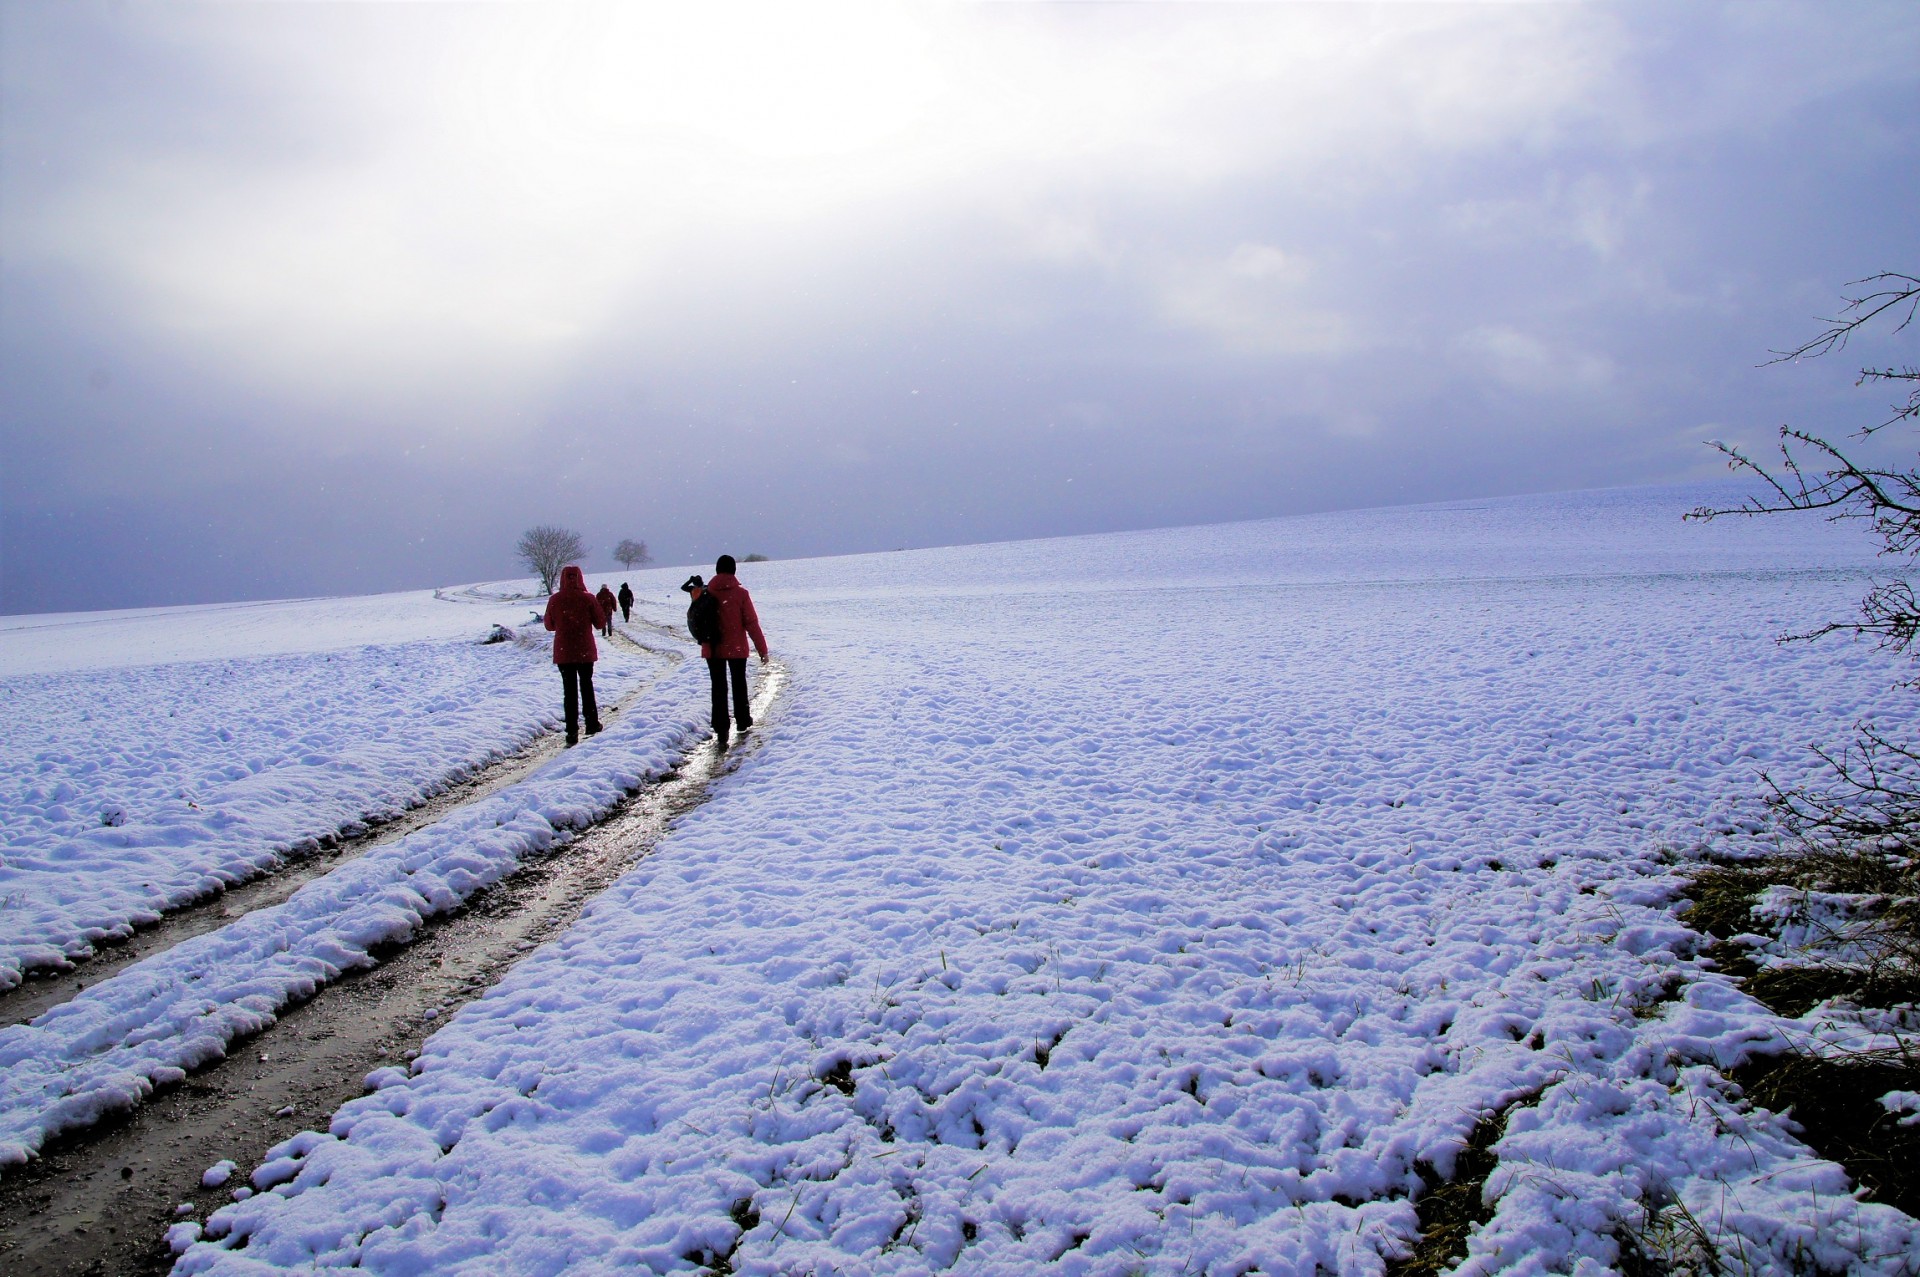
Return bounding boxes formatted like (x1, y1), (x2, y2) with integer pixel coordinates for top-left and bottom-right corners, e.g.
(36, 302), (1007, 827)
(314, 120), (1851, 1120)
(0, 664), (785, 1277)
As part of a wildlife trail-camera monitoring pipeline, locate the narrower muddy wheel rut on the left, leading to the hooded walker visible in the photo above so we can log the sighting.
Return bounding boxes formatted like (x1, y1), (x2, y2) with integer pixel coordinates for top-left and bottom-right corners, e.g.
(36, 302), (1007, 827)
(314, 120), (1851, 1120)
(0, 626), (685, 1027)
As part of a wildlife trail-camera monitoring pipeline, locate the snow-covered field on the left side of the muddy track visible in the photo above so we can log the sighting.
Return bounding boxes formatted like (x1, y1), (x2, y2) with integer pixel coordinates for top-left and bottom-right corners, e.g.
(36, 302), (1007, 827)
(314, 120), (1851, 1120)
(0, 591), (668, 987)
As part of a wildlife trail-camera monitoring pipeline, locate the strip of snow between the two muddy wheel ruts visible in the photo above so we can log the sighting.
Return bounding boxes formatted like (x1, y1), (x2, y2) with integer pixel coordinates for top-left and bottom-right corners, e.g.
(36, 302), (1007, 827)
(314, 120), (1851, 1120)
(0, 661), (721, 1166)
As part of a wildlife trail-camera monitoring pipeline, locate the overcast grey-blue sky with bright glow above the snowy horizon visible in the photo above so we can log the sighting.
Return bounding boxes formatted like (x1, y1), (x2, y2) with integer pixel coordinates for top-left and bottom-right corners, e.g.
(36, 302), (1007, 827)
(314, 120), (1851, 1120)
(0, 0), (1920, 613)
